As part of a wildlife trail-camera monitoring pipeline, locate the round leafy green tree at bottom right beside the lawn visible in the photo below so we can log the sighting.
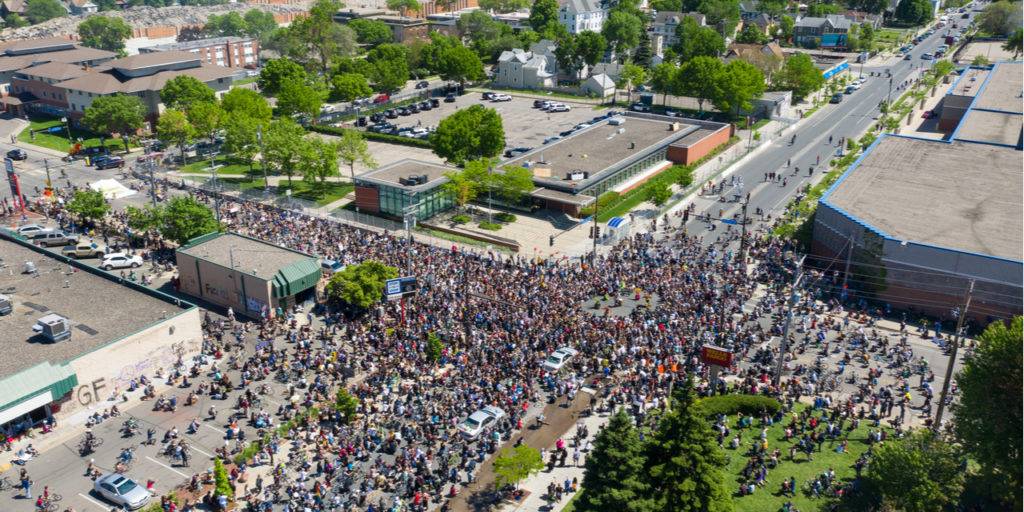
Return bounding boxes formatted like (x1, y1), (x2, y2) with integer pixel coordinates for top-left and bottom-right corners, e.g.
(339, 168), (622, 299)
(863, 428), (962, 512)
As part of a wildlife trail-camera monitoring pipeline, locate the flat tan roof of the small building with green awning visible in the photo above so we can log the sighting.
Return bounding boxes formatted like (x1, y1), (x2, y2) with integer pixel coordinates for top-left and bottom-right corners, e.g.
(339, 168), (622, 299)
(178, 232), (312, 281)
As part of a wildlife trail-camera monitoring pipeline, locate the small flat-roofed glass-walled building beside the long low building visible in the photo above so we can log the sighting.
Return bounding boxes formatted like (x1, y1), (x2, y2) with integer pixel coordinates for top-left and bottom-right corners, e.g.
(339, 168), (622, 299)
(355, 159), (457, 220)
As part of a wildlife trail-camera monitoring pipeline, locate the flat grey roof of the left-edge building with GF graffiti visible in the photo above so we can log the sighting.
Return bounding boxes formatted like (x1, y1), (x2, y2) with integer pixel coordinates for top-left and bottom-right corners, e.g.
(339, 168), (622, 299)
(0, 237), (193, 379)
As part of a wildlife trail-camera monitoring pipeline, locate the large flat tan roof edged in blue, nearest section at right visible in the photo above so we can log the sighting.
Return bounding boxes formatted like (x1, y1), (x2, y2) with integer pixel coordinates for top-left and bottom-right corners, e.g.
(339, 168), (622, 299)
(822, 136), (1024, 260)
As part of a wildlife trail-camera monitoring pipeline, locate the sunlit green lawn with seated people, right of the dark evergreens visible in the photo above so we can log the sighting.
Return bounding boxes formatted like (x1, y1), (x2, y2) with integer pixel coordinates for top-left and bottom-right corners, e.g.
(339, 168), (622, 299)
(724, 406), (891, 512)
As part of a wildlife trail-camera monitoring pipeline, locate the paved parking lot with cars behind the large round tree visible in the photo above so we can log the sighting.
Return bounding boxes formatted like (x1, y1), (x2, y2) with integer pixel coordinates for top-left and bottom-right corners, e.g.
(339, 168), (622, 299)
(366, 92), (604, 150)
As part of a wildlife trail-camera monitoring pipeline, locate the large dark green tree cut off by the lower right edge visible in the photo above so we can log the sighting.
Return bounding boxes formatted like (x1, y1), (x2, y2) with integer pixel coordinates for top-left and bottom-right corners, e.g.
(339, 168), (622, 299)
(954, 316), (1024, 510)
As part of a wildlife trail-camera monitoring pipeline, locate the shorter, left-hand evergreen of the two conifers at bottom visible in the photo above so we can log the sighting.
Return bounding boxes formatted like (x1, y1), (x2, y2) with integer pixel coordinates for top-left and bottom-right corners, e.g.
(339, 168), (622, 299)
(575, 409), (652, 512)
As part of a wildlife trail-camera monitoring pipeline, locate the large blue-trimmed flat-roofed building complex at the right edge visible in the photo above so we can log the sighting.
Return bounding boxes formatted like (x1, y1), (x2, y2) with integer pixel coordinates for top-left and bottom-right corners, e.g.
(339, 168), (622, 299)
(812, 62), (1024, 322)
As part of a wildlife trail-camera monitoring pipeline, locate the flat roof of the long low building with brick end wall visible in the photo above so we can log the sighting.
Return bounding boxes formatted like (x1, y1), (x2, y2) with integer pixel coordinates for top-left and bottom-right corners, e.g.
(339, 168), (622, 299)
(502, 115), (701, 189)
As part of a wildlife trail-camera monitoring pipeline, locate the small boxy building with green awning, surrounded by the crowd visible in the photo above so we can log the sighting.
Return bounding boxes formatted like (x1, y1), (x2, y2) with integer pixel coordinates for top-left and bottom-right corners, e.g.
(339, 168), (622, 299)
(177, 232), (322, 318)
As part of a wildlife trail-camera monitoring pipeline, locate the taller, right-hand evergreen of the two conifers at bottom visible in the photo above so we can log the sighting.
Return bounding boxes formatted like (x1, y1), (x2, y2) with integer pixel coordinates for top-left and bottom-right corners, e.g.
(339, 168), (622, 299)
(645, 378), (732, 512)
